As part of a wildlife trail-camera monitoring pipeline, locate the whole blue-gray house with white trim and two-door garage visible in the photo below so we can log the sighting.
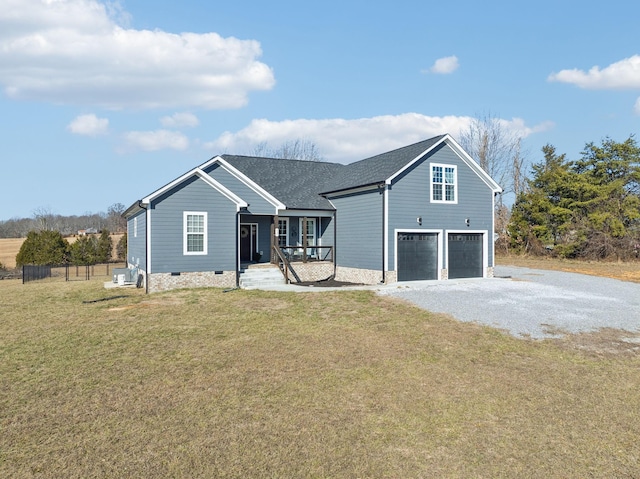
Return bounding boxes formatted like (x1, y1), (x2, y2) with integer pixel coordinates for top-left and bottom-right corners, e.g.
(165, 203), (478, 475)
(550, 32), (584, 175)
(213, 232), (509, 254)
(124, 135), (502, 291)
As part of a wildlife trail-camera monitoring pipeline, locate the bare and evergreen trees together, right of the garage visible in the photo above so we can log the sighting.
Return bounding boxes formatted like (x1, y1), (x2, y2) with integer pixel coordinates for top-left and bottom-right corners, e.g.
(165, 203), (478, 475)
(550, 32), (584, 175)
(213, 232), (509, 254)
(460, 115), (640, 260)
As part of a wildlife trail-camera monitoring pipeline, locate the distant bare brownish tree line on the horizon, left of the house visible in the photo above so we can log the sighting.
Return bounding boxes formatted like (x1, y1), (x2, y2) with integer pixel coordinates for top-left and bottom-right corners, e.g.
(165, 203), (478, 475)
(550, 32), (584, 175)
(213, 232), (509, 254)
(0, 203), (127, 238)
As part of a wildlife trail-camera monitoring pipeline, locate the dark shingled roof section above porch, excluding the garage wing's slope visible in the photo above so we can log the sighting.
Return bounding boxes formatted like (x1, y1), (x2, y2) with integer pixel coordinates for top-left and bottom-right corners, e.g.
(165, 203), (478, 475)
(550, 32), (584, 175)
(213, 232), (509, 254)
(222, 155), (346, 210)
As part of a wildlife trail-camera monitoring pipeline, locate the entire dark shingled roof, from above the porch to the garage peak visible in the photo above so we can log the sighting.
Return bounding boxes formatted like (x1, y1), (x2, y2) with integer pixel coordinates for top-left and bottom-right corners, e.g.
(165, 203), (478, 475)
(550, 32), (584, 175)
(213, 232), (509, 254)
(222, 135), (445, 209)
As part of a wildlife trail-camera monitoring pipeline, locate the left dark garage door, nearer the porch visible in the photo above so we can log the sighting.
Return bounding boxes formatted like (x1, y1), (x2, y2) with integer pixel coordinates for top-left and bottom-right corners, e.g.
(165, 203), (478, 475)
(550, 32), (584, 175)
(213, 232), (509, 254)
(398, 233), (438, 281)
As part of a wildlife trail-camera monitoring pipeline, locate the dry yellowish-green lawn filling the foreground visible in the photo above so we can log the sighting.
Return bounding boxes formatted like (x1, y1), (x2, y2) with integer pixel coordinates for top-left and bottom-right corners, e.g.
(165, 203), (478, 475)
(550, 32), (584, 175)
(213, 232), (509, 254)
(0, 281), (640, 478)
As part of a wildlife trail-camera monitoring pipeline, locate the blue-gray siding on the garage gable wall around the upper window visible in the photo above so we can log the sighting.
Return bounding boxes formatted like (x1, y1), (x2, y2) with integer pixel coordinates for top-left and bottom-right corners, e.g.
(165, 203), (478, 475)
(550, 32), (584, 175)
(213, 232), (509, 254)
(388, 145), (493, 269)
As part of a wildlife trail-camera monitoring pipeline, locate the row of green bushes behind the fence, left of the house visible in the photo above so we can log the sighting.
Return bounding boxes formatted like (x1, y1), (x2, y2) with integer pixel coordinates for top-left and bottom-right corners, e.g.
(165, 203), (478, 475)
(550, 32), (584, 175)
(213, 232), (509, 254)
(16, 229), (127, 267)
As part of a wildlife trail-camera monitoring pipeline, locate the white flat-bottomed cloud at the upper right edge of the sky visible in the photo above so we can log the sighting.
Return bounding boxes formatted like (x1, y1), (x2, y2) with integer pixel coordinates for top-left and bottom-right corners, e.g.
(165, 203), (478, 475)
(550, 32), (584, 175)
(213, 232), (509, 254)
(548, 55), (640, 90)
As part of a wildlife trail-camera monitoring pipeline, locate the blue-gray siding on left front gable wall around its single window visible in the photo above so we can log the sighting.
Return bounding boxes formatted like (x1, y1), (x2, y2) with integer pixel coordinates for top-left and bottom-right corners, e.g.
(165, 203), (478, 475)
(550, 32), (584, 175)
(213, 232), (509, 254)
(150, 177), (237, 273)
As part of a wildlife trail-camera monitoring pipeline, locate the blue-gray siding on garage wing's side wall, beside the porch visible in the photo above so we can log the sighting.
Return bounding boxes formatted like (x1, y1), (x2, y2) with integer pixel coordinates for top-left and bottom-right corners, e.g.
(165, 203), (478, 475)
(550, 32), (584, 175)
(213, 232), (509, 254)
(329, 190), (383, 271)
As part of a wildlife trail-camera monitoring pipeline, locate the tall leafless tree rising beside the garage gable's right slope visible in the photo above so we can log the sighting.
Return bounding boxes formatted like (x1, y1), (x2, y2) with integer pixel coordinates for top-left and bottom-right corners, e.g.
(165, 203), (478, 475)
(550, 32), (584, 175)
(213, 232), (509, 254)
(460, 114), (526, 203)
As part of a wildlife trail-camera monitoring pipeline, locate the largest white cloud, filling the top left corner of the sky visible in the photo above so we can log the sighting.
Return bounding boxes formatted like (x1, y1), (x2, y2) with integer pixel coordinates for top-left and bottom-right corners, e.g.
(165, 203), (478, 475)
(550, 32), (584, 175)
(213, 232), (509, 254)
(0, 0), (275, 109)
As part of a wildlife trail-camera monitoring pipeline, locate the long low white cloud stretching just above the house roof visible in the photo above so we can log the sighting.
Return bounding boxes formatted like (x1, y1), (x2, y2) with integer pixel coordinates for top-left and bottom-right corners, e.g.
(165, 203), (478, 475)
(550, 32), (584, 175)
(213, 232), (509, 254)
(204, 113), (549, 163)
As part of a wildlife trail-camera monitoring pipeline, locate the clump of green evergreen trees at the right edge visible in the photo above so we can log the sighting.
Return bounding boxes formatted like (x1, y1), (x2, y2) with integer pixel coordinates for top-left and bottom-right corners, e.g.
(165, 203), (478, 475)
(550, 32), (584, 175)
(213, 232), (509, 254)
(509, 136), (640, 259)
